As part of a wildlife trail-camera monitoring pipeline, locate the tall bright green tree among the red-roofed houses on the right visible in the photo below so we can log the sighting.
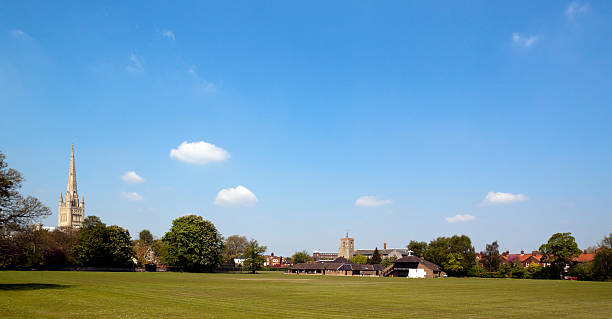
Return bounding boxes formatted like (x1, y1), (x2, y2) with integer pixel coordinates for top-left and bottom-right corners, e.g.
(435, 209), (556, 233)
(540, 233), (582, 277)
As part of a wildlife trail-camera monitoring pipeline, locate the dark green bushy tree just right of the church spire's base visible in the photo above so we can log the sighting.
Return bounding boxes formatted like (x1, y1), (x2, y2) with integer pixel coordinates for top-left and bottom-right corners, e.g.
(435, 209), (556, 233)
(73, 216), (134, 267)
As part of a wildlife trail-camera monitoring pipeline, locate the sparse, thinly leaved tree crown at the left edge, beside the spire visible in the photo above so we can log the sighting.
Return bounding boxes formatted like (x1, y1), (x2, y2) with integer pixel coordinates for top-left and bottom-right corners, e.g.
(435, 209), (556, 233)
(0, 152), (51, 232)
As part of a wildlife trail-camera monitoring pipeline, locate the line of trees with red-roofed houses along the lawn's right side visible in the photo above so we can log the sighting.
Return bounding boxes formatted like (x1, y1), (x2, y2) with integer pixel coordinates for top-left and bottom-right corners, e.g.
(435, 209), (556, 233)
(406, 233), (612, 280)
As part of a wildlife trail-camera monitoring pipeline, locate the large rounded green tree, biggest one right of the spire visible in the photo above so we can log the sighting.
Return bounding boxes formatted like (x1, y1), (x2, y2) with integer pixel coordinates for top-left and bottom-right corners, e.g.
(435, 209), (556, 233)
(162, 215), (223, 271)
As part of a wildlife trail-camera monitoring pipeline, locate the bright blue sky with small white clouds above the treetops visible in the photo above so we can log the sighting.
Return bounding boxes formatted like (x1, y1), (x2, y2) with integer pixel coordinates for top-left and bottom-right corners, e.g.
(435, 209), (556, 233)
(0, 1), (612, 255)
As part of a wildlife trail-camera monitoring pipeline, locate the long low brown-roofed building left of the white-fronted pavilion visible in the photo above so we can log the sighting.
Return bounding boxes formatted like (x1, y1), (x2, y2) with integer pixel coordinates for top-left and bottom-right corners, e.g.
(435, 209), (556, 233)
(287, 257), (384, 277)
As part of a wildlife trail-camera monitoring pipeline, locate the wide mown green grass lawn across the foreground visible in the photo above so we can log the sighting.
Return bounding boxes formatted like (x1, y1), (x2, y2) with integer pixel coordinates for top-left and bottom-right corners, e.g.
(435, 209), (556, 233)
(0, 271), (612, 318)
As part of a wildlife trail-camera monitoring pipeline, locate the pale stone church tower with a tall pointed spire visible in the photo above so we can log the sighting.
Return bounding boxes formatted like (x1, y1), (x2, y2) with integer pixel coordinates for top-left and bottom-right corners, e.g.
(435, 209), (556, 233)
(57, 145), (85, 227)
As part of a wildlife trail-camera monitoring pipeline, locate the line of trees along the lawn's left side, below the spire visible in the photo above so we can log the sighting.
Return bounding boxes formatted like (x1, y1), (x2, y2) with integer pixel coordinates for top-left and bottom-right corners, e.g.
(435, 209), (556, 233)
(0, 152), (266, 272)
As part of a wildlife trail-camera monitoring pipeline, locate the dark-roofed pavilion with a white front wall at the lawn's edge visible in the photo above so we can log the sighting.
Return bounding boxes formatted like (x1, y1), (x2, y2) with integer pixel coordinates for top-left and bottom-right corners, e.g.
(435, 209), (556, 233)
(382, 256), (446, 278)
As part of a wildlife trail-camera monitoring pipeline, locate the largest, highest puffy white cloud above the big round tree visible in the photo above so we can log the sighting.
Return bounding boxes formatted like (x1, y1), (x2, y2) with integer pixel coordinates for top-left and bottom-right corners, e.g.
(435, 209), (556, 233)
(170, 141), (230, 164)
